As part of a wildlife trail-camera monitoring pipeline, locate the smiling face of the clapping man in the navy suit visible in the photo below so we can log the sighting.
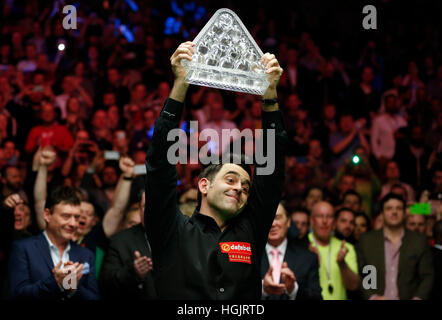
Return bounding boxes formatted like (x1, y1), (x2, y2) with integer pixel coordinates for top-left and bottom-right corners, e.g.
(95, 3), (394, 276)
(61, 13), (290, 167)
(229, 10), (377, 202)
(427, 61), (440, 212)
(44, 202), (81, 243)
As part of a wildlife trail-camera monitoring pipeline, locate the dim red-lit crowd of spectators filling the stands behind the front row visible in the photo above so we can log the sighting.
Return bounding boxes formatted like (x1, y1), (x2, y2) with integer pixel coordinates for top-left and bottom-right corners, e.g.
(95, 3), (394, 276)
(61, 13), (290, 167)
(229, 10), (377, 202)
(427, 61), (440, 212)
(0, 0), (442, 298)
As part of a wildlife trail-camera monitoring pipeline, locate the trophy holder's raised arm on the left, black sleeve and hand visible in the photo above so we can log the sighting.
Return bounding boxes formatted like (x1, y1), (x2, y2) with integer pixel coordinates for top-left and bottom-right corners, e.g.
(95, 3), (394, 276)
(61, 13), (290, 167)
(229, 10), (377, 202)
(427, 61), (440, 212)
(144, 42), (194, 252)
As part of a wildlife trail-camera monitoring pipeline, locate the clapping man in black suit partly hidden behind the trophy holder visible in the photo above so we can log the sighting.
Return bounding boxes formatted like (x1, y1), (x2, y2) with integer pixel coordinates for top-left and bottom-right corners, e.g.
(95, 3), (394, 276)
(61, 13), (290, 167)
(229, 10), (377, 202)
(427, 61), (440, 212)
(99, 192), (156, 300)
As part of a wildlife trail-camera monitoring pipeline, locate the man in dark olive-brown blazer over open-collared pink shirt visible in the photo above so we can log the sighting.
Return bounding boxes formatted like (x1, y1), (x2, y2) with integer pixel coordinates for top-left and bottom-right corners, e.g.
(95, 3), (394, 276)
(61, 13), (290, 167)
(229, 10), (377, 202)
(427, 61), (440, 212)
(358, 193), (434, 300)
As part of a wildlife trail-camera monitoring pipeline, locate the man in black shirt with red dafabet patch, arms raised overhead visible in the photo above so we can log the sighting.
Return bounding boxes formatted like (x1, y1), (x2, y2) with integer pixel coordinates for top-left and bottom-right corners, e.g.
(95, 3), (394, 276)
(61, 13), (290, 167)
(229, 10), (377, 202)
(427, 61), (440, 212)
(145, 36), (287, 300)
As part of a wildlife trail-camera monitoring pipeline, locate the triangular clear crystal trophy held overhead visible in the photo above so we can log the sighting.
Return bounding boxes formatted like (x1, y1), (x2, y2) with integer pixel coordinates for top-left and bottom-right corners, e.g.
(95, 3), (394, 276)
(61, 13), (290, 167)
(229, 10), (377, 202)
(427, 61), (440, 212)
(182, 8), (269, 95)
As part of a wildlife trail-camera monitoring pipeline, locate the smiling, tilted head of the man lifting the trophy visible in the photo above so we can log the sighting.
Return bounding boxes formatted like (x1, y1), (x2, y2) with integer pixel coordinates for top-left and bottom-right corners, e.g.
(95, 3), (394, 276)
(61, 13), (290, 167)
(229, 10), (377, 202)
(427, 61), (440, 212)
(198, 163), (250, 221)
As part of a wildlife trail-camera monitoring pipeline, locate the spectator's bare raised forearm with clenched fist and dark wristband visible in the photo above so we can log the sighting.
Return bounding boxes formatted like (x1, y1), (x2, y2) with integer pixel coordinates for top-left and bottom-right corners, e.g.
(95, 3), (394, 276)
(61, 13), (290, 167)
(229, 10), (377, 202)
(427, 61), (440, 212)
(103, 157), (135, 238)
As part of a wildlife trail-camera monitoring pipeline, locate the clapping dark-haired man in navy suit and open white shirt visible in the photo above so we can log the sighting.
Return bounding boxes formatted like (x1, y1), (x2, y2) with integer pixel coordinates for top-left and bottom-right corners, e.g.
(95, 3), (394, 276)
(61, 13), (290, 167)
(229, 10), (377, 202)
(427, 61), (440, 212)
(9, 187), (99, 300)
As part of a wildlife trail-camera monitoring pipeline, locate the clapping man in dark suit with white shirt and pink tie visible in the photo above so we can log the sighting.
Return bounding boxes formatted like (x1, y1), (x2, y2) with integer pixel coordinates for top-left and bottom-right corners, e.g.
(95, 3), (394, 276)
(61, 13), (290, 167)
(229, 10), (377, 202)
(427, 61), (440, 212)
(261, 203), (322, 300)
